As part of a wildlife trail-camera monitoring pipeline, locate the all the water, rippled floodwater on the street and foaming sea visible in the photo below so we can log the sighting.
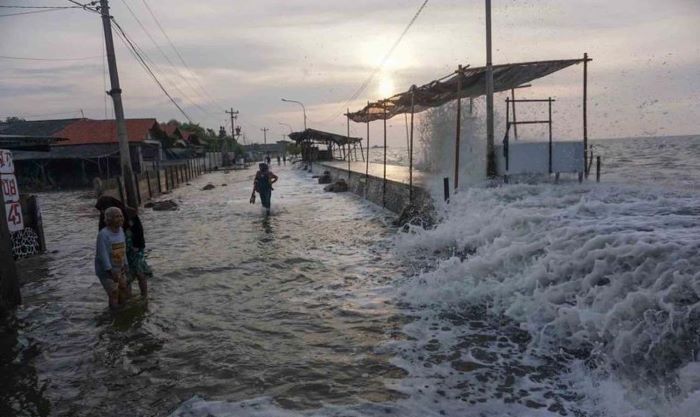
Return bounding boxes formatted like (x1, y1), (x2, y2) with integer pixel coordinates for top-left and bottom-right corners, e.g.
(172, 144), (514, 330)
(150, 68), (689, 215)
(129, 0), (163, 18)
(0, 136), (700, 417)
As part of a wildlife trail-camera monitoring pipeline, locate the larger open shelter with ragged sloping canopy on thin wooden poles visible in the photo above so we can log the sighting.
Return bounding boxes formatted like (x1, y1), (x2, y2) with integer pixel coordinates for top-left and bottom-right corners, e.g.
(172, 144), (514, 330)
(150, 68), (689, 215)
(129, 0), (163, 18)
(346, 54), (590, 204)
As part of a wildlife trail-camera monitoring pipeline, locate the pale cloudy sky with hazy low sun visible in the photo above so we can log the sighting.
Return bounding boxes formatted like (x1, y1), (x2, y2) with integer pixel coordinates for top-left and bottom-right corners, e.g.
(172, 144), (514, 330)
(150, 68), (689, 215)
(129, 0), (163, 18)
(0, 0), (700, 144)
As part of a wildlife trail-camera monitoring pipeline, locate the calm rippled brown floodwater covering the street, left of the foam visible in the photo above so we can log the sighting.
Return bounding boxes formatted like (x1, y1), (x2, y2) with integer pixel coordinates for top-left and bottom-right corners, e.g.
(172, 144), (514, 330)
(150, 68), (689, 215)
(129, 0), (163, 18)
(0, 166), (404, 416)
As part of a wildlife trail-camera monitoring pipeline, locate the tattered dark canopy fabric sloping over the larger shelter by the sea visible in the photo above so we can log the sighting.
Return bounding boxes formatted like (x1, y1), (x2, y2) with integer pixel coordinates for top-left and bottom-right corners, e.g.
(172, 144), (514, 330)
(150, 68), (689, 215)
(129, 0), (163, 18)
(347, 58), (583, 123)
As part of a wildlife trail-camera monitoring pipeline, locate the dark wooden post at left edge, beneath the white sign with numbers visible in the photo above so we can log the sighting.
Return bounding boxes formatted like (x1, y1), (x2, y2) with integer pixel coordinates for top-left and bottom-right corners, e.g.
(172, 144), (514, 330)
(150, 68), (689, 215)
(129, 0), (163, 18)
(0, 189), (22, 314)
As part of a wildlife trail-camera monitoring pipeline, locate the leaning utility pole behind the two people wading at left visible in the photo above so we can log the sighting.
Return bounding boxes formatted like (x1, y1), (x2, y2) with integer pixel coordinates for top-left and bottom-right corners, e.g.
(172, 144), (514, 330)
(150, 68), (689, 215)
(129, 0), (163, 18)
(100, 0), (139, 207)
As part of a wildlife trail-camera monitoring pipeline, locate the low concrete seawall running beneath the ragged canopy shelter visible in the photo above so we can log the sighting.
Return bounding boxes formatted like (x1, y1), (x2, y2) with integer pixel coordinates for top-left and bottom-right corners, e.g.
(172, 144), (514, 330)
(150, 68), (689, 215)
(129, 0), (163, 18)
(313, 161), (432, 214)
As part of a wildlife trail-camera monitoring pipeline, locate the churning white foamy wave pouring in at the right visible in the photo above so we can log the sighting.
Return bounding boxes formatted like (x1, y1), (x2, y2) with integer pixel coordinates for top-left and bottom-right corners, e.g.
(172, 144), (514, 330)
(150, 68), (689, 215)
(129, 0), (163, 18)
(392, 184), (700, 417)
